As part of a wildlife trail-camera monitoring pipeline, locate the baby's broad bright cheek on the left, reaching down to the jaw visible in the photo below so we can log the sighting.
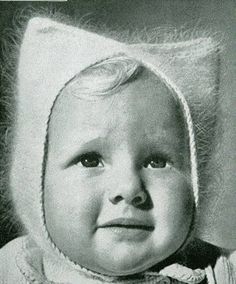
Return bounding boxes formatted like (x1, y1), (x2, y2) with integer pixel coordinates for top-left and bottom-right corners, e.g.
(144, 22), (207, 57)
(44, 169), (107, 265)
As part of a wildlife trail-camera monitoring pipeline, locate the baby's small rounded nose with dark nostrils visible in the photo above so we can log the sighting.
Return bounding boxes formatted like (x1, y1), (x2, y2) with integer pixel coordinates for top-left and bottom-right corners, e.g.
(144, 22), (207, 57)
(109, 170), (147, 207)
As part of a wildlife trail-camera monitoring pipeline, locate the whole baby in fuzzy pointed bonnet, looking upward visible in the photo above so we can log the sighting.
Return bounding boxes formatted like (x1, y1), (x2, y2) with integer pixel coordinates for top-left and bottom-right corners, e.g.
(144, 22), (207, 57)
(0, 18), (235, 284)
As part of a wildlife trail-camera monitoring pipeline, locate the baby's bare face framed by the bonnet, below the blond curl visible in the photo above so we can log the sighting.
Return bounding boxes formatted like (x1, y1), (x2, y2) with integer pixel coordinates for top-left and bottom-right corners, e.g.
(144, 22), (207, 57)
(45, 72), (193, 275)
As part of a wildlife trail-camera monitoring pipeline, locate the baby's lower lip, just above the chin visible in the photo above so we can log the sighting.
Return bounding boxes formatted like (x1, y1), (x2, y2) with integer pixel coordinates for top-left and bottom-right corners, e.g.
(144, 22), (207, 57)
(97, 226), (153, 241)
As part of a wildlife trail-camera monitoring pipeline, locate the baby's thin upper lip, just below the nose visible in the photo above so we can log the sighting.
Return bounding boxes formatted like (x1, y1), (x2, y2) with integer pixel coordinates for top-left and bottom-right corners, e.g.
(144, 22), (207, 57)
(98, 218), (154, 231)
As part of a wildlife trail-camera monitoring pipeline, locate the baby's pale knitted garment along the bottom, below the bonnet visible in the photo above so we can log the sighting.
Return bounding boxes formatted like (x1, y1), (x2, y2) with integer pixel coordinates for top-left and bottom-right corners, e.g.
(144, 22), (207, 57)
(0, 236), (236, 284)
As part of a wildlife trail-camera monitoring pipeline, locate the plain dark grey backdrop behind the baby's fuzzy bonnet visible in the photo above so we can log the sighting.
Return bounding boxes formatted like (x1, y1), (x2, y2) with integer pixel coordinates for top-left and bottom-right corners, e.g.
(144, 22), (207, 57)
(0, 0), (236, 248)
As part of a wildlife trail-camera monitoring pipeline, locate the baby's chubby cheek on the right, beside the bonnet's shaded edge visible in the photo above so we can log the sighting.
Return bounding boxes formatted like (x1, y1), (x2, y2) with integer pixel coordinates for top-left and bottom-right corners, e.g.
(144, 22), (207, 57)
(150, 174), (194, 246)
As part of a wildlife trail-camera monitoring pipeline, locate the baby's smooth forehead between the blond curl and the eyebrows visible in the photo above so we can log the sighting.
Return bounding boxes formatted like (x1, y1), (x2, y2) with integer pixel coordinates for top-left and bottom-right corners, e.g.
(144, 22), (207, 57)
(50, 71), (183, 150)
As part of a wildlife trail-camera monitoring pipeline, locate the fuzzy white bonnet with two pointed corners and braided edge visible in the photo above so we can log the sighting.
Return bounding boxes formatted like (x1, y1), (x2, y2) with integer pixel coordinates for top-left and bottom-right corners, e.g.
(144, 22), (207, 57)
(10, 18), (218, 282)
